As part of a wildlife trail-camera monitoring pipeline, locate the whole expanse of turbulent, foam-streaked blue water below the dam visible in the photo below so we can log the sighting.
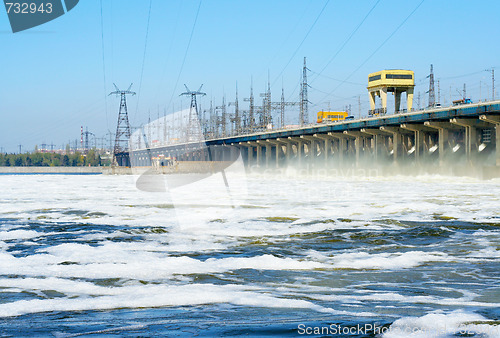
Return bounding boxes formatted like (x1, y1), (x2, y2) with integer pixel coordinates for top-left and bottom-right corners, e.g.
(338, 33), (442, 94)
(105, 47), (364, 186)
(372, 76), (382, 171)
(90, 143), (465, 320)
(0, 172), (500, 337)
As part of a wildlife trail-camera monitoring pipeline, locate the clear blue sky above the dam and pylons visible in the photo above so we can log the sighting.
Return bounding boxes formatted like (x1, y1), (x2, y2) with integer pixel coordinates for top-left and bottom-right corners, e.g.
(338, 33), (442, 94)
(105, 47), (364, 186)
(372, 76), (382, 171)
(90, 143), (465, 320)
(0, 0), (500, 152)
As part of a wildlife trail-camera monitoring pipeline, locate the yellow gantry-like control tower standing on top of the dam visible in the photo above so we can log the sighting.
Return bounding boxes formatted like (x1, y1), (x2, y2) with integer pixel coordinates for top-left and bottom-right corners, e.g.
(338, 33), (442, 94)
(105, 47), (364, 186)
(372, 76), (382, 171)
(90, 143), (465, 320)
(367, 69), (415, 115)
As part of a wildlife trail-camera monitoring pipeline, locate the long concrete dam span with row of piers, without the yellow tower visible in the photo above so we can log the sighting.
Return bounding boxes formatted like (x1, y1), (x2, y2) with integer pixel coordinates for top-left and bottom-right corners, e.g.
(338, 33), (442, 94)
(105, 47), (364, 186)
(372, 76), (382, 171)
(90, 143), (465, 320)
(130, 100), (500, 170)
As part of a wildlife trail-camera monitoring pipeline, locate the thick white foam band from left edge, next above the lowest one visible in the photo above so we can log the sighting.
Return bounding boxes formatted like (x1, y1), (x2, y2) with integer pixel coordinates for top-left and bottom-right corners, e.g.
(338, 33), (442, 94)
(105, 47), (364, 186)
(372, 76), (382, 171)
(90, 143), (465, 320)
(0, 248), (329, 280)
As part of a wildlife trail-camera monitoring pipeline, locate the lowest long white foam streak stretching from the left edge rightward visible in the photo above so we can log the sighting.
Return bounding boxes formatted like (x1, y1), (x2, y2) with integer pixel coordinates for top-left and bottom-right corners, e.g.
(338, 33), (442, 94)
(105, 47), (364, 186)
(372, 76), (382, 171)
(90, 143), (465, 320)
(0, 279), (362, 317)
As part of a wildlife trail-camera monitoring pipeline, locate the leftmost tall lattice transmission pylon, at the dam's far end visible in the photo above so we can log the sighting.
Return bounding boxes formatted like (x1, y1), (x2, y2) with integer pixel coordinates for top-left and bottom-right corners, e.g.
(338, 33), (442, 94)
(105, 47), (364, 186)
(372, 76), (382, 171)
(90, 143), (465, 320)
(109, 83), (135, 166)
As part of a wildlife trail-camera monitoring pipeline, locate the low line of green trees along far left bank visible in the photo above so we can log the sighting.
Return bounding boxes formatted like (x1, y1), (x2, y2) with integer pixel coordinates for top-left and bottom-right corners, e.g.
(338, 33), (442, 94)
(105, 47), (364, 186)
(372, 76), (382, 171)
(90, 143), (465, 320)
(0, 149), (110, 167)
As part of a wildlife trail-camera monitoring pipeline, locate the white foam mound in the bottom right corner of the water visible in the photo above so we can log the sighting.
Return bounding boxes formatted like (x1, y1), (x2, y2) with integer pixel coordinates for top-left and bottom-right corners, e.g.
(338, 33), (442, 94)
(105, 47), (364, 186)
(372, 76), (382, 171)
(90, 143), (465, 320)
(383, 310), (500, 338)
